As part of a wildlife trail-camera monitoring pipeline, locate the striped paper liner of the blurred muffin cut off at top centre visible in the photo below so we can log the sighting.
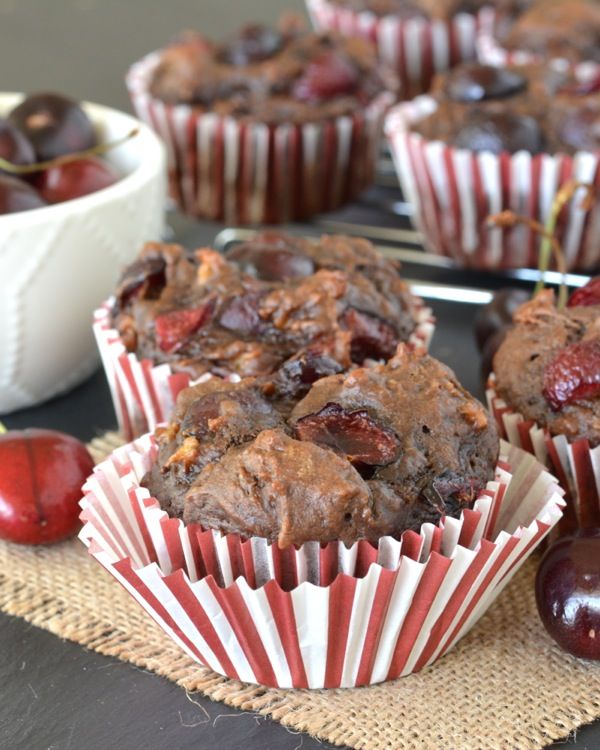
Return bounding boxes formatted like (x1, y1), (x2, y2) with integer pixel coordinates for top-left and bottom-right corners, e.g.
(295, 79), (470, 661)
(306, 0), (495, 99)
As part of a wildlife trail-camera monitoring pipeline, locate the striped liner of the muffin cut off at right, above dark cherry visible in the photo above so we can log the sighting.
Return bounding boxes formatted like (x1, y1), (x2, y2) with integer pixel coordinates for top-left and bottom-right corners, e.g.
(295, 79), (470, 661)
(486, 382), (600, 533)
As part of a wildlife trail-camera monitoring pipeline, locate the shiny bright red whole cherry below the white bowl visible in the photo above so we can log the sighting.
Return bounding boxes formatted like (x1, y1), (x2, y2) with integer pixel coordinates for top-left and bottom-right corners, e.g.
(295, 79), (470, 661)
(0, 429), (94, 544)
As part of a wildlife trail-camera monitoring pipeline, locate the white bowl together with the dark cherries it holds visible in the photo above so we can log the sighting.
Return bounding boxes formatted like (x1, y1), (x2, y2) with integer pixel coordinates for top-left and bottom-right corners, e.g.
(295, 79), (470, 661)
(0, 93), (166, 413)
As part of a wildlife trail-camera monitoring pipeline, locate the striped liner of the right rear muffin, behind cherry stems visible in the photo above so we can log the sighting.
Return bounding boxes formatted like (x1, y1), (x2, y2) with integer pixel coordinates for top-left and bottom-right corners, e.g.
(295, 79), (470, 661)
(385, 96), (600, 270)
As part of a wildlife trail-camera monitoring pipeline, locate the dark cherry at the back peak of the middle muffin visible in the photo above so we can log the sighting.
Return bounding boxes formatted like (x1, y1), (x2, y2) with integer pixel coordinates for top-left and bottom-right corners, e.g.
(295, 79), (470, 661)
(227, 232), (315, 281)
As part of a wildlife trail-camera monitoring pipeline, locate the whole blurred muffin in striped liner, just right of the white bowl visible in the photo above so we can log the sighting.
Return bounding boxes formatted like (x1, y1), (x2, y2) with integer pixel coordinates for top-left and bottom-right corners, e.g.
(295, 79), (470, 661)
(126, 19), (396, 224)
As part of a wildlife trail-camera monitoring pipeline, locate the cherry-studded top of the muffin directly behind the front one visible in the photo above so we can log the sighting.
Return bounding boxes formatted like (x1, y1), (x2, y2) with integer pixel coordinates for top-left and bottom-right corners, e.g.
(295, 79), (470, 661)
(113, 232), (422, 394)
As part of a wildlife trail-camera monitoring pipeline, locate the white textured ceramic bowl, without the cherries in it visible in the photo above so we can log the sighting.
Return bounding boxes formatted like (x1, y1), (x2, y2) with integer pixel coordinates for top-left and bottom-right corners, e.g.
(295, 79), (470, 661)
(0, 94), (166, 413)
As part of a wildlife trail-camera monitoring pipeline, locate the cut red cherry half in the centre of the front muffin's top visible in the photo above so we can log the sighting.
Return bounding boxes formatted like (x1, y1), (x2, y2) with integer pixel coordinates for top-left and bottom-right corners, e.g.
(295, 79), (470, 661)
(295, 403), (398, 466)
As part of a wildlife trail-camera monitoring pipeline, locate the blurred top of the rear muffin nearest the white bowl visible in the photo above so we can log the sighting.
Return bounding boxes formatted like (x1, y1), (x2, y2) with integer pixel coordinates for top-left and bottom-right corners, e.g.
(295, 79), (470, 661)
(150, 21), (396, 123)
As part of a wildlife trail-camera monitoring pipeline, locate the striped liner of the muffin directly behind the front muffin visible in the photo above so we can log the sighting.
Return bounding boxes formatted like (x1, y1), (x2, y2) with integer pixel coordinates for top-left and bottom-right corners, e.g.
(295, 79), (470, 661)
(93, 297), (435, 440)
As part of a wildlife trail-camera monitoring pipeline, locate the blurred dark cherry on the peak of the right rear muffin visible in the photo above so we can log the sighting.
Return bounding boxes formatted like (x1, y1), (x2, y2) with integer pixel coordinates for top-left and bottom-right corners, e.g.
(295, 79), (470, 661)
(445, 63), (527, 102)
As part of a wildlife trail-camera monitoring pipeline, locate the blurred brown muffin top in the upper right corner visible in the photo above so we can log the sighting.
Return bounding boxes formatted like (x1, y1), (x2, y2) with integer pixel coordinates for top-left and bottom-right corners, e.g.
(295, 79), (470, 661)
(498, 0), (600, 63)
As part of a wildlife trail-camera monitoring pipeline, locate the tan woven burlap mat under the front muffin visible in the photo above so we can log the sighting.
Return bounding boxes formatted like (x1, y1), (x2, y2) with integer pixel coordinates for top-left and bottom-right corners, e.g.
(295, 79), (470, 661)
(0, 435), (600, 750)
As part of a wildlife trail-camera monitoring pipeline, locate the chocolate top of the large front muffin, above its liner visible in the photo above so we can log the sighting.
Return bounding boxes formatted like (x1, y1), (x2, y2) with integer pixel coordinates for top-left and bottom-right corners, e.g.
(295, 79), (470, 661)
(142, 345), (498, 547)
